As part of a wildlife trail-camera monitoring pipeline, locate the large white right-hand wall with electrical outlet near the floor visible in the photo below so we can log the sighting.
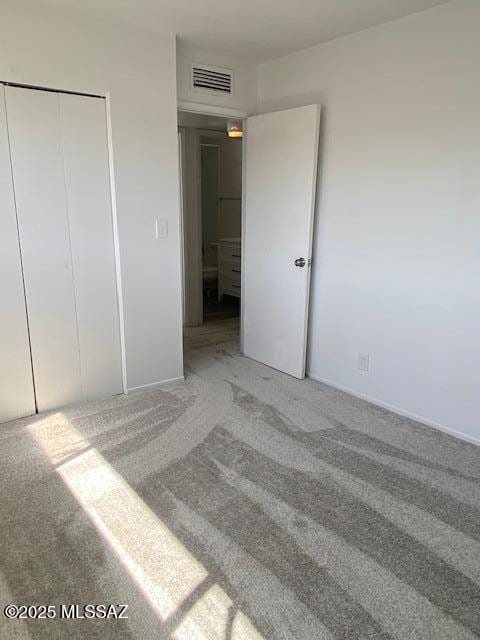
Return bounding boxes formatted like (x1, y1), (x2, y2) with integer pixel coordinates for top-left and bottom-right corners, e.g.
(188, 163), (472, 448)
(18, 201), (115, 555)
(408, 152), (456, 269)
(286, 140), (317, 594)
(258, 0), (480, 441)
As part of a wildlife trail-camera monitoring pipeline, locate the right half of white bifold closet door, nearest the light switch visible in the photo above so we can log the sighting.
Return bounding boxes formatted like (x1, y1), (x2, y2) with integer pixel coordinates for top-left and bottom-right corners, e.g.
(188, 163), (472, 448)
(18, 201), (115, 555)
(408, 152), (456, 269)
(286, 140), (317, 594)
(59, 94), (123, 399)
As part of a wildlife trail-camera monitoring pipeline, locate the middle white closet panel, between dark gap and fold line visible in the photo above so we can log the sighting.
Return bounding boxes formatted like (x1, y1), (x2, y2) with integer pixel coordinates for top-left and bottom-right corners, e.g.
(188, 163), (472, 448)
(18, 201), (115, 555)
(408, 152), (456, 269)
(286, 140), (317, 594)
(5, 87), (82, 411)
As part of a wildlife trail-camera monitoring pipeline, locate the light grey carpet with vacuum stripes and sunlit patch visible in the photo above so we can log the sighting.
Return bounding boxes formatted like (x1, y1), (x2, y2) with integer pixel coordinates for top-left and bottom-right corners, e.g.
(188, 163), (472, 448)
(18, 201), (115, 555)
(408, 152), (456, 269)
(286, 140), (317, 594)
(0, 328), (480, 640)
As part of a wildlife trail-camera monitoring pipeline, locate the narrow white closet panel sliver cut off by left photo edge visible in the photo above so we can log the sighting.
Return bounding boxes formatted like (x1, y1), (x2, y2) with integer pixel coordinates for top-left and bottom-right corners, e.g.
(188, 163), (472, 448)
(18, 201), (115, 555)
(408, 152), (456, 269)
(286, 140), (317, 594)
(0, 85), (35, 422)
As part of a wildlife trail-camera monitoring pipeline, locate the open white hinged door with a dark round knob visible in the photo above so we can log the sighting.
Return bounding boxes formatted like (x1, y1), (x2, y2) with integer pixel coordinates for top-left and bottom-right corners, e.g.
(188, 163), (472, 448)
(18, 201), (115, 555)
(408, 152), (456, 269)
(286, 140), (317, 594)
(242, 105), (320, 378)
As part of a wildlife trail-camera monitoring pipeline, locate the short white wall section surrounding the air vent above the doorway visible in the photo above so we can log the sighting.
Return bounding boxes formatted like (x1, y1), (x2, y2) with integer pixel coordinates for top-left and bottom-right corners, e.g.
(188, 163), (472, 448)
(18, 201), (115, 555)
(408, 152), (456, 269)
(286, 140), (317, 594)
(177, 46), (257, 114)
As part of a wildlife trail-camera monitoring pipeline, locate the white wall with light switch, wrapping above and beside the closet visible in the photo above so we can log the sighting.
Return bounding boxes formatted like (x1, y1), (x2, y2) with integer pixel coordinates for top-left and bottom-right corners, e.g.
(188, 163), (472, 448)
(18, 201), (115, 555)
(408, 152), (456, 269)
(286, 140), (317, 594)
(0, 0), (183, 388)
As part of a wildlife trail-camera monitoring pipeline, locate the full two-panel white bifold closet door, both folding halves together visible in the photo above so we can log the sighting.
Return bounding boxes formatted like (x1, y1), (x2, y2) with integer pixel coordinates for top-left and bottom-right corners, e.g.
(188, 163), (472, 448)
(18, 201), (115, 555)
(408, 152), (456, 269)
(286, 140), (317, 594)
(5, 87), (123, 411)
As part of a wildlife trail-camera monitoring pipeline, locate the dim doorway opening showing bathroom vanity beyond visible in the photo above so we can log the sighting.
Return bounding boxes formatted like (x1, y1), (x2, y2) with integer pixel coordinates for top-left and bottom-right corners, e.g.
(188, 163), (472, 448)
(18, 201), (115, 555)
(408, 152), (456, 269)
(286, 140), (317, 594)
(178, 111), (242, 351)
